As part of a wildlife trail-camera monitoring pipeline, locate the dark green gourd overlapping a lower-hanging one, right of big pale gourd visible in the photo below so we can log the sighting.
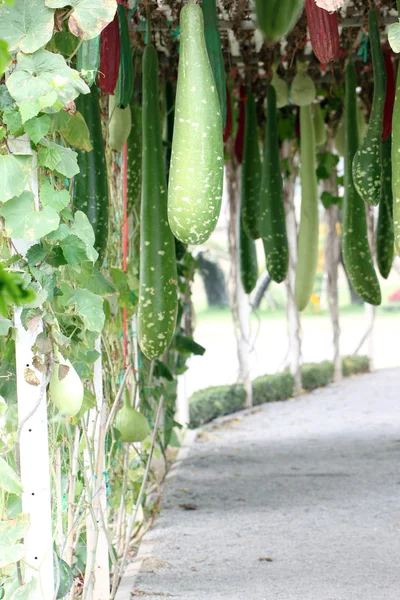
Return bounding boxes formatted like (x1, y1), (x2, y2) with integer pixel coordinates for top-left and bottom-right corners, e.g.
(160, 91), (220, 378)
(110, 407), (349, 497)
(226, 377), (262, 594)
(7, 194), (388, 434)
(241, 90), (261, 240)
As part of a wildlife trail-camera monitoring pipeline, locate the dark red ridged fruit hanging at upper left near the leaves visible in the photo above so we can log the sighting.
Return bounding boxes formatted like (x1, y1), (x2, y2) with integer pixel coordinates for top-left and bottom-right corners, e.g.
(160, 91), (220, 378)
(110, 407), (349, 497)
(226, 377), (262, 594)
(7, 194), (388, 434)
(98, 12), (121, 94)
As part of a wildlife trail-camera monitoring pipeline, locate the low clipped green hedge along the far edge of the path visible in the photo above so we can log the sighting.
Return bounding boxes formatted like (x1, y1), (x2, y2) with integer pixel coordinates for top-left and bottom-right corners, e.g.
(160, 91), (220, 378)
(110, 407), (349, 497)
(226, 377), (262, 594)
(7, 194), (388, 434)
(189, 356), (369, 429)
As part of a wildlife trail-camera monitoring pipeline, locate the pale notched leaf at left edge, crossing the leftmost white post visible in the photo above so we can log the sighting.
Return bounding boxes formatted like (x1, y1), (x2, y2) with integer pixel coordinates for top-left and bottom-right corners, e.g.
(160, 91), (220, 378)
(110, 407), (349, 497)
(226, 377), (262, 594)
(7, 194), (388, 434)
(0, 192), (60, 241)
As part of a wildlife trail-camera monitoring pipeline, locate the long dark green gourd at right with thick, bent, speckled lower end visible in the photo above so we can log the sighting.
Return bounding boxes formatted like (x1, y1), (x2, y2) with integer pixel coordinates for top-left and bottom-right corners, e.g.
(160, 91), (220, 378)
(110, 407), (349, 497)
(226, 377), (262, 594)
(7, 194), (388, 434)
(342, 63), (381, 305)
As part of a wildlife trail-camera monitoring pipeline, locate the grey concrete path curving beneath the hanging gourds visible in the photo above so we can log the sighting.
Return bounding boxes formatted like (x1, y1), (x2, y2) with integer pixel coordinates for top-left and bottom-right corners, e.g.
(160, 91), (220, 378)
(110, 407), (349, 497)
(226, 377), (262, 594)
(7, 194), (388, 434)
(126, 370), (400, 600)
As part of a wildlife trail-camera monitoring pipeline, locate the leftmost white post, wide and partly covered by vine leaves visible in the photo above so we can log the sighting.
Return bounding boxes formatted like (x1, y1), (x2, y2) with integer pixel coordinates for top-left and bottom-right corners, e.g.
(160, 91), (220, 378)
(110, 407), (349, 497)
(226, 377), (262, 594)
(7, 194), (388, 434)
(10, 136), (54, 600)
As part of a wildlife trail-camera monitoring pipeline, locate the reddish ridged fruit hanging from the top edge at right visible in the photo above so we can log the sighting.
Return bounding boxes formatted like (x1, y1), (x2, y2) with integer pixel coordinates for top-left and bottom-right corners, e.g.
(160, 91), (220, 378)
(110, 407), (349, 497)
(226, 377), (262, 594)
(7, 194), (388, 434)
(306, 0), (339, 65)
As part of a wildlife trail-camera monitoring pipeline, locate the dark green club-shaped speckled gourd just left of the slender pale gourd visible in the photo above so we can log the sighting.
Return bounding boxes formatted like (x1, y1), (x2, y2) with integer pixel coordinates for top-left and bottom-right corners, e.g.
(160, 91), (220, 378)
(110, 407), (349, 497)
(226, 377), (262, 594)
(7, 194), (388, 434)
(260, 85), (289, 283)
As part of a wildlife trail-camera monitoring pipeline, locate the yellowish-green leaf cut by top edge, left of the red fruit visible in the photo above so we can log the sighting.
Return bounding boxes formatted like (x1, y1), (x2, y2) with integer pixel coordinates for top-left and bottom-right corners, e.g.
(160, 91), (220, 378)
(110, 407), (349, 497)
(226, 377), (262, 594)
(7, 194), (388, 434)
(46, 0), (117, 40)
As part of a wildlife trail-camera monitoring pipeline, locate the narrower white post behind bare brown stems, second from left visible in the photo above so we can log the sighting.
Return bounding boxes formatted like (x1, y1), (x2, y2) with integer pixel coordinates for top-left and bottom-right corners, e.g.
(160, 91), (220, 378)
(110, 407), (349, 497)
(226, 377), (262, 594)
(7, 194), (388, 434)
(85, 338), (110, 600)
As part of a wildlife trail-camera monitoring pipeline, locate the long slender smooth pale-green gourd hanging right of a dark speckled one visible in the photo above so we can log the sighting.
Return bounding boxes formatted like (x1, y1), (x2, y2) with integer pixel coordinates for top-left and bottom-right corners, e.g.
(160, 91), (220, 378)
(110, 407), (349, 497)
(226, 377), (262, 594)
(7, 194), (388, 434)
(294, 104), (319, 310)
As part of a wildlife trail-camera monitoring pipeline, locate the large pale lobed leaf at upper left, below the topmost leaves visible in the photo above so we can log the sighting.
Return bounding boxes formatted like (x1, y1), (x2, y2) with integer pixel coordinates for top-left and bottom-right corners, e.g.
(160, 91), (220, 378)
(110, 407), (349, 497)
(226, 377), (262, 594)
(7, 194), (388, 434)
(7, 49), (90, 108)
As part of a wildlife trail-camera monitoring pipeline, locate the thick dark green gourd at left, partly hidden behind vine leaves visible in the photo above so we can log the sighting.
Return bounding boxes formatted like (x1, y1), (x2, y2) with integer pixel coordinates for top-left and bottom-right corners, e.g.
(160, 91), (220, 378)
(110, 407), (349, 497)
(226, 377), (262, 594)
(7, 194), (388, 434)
(73, 85), (109, 265)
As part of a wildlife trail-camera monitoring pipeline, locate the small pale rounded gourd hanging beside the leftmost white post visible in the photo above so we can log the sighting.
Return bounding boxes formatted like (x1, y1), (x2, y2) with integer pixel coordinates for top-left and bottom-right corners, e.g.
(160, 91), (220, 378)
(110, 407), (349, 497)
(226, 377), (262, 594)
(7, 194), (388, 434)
(49, 349), (84, 417)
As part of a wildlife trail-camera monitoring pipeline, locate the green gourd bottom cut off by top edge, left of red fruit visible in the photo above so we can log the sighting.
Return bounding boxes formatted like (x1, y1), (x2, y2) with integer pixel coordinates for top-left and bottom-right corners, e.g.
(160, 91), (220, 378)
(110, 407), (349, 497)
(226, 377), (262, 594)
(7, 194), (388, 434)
(256, 0), (304, 42)
